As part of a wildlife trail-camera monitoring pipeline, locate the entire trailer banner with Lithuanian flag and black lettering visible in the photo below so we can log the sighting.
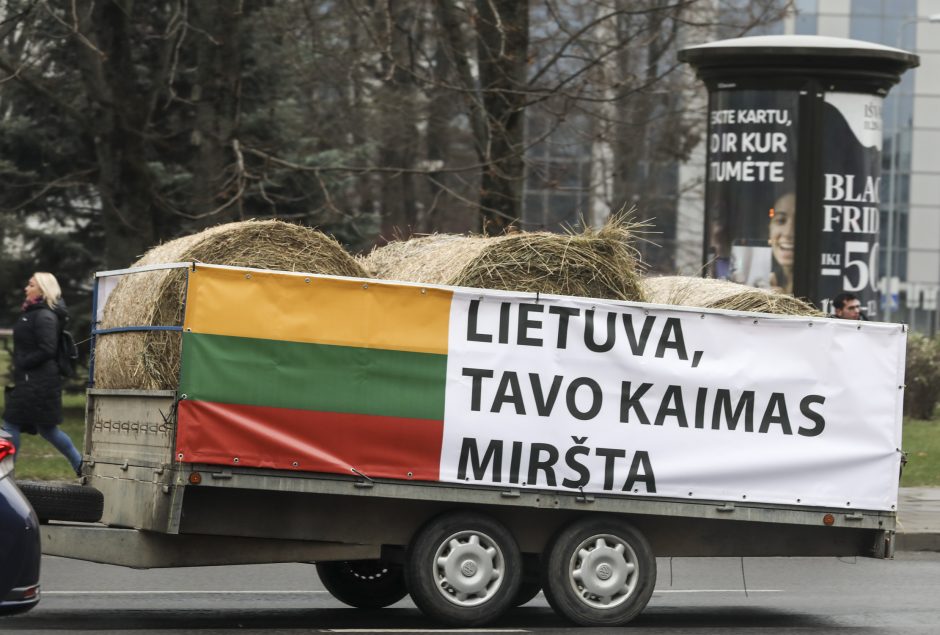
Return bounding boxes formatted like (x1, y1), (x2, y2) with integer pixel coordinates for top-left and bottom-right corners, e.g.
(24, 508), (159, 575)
(176, 265), (905, 511)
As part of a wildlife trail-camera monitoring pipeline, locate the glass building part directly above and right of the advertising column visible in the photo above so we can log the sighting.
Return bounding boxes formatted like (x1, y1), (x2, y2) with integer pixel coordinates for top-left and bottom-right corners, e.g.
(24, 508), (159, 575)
(785, 0), (940, 333)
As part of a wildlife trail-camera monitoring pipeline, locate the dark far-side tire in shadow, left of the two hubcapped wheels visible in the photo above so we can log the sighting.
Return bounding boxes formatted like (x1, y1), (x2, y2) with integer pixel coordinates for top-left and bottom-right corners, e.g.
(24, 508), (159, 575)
(317, 560), (408, 609)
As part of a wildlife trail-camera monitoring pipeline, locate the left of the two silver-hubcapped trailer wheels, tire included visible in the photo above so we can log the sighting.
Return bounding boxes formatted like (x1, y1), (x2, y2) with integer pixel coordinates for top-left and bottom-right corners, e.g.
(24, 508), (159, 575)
(405, 512), (522, 627)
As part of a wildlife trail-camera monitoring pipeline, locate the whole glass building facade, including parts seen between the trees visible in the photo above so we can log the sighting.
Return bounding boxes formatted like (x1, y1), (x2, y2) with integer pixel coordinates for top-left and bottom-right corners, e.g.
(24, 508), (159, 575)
(523, 0), (940, 333)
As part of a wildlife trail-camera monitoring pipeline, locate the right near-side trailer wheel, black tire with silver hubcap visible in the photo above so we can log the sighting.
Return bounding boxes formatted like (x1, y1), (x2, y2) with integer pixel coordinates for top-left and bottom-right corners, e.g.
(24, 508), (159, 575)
(542, 517), (656, 626)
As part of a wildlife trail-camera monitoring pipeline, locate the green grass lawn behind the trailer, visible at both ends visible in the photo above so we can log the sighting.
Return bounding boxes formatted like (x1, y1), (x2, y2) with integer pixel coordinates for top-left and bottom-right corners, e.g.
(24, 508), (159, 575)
(0, 348), (940, 487)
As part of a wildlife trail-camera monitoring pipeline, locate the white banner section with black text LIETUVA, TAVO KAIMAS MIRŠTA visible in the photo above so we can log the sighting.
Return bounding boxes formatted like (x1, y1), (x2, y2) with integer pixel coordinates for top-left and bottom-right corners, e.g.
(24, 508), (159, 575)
(440, 291), (906, 510)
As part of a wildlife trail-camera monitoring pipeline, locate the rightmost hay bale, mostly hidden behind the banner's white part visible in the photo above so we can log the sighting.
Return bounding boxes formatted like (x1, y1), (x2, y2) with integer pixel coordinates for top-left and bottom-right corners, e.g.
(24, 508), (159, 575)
(643, 276), (825, 317)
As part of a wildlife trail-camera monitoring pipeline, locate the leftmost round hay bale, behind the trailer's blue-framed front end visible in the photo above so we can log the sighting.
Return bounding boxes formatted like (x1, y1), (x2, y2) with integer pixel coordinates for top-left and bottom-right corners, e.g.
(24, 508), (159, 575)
(95, 220), (366, 390)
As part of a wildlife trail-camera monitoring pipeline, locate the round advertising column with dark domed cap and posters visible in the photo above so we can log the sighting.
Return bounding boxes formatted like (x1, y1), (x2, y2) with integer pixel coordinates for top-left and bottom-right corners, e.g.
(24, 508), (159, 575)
(679, 35), (919, 319)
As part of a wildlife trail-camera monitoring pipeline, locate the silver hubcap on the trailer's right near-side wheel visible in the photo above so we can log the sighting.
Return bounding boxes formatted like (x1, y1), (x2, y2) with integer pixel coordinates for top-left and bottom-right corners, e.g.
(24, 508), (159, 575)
(568, 534), (638, 609)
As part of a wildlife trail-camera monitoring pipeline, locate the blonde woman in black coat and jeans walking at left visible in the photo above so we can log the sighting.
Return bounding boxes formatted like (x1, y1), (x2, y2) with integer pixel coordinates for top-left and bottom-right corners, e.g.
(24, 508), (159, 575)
(3, 272), (82, 475)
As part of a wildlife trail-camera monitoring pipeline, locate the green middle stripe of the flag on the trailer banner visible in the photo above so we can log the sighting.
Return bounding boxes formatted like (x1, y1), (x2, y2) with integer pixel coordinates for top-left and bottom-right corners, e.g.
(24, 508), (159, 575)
(180, 333), (447, 420)
